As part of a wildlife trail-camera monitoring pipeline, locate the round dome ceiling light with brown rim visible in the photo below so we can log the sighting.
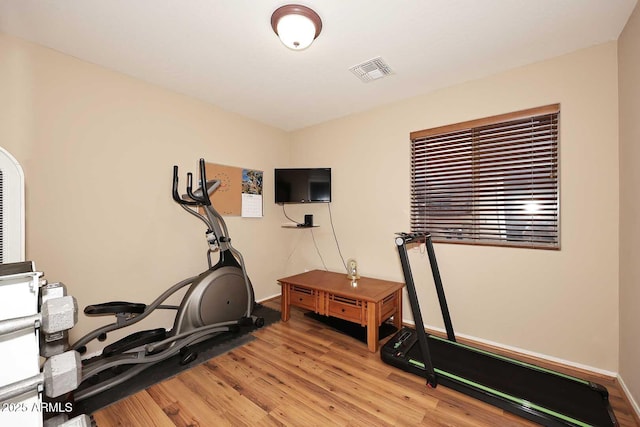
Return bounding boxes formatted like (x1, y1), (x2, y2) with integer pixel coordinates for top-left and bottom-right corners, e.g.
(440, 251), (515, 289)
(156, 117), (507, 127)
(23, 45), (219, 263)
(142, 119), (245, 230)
(271, 4), (322, 50)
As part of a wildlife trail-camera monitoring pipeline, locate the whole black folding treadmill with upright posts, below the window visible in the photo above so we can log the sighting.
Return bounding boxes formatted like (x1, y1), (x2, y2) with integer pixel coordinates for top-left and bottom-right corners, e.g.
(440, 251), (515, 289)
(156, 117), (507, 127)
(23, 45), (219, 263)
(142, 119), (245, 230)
(380, 233), (619, 426)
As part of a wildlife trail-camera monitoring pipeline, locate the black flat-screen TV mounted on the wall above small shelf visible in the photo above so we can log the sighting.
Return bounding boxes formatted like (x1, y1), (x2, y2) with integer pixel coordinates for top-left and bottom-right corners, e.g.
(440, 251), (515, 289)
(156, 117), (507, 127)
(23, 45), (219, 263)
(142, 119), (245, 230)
(274, 168), (331, 204)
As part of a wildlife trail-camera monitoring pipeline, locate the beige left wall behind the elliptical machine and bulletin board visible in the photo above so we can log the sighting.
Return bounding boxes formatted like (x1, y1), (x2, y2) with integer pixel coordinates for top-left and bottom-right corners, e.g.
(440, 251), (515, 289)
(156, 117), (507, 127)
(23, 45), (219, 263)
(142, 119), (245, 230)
(0, 34), (289, 352)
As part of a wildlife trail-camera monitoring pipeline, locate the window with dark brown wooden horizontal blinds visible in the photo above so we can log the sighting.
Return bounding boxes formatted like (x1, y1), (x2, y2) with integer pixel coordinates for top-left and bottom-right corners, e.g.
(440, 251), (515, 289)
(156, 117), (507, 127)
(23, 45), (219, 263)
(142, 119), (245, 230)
(411, 104), (560, 249)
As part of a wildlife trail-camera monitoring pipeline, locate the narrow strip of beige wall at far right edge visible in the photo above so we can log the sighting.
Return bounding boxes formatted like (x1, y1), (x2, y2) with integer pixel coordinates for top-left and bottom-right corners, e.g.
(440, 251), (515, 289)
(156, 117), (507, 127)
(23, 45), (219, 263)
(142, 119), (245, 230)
(618, 1), (640, 412)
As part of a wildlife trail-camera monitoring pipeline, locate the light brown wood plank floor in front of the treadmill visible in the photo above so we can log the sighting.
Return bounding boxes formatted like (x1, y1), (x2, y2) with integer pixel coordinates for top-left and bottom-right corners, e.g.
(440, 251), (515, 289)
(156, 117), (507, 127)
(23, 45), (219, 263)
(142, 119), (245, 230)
(94, 299), (640, 427)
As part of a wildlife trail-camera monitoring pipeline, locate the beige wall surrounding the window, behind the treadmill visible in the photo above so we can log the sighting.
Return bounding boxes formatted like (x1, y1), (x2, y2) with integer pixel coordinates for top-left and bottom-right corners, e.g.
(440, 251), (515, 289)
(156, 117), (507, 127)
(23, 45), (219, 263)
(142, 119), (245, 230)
(287, 42), (618, 371)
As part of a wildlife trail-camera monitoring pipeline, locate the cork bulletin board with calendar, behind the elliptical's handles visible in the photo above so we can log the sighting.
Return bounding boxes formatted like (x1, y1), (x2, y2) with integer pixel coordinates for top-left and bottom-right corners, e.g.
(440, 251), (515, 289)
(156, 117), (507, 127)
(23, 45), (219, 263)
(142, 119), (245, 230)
(205, 163), (263, 218)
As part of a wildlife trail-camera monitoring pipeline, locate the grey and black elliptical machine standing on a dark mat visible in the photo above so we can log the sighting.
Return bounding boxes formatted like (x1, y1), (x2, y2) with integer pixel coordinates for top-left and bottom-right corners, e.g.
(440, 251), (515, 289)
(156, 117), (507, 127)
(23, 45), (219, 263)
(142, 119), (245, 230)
(71, 159), (264, 401)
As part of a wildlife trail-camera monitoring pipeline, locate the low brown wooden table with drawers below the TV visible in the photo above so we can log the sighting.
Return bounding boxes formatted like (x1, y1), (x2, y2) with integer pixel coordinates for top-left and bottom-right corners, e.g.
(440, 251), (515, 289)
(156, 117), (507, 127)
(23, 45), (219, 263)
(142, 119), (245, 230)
(278, 270), (404, 352)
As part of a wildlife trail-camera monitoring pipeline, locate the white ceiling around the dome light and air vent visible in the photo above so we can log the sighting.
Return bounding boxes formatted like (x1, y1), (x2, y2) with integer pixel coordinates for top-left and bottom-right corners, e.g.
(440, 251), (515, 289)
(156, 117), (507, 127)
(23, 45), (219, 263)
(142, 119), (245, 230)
(0, 0), (637, 130)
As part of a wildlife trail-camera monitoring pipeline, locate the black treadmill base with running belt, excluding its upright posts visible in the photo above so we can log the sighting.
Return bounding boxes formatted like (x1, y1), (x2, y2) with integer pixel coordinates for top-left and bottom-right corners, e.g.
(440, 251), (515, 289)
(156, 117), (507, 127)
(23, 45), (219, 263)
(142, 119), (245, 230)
(381, 329), (615, 426)
